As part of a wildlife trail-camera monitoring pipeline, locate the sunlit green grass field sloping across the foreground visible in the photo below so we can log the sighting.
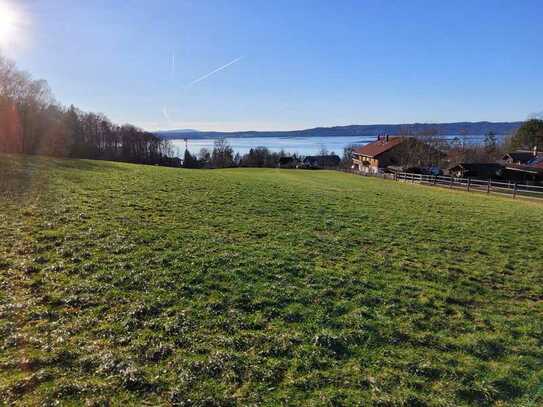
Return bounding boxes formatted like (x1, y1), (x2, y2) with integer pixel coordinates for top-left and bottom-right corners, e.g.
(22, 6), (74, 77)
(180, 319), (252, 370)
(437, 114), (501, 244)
(0, 156), (543, 406)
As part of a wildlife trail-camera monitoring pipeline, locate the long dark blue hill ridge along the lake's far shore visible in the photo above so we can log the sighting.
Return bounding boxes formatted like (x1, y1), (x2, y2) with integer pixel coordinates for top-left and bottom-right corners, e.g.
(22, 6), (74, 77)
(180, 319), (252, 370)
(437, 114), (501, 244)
(155, 122), (522, 140)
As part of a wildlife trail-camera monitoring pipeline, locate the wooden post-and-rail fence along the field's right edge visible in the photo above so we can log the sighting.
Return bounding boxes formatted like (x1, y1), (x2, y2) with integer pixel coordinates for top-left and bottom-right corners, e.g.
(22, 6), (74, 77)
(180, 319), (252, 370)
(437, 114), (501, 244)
(347, 170), (543, 199)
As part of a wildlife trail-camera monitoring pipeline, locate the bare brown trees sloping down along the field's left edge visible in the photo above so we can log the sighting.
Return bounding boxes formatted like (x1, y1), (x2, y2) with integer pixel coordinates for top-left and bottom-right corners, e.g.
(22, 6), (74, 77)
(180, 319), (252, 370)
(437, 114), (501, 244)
(0, 56), (180, 166)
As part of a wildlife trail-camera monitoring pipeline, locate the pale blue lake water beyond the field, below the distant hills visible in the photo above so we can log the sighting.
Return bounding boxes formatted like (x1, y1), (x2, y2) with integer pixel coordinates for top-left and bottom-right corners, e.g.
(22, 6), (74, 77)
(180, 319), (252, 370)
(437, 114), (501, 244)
(171, 135), (503, 157)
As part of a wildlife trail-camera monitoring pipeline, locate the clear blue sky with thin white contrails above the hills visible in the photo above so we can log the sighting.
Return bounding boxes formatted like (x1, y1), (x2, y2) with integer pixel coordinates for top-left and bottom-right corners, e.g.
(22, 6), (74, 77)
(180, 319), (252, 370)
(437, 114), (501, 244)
(4, 0), (543, 131)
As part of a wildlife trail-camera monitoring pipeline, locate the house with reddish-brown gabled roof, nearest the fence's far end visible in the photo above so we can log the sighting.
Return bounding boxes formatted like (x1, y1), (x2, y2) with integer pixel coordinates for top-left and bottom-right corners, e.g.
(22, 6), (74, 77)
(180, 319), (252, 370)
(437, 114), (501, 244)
(352, 136), (405, 174)
